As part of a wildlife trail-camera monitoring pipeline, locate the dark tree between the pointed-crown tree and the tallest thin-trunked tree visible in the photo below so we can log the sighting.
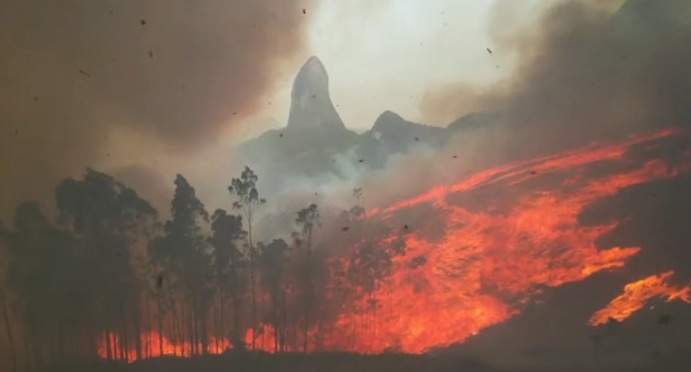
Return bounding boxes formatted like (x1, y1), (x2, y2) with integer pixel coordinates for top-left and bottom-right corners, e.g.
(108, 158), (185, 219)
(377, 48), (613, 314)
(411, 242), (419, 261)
(209, 209), (247, 346)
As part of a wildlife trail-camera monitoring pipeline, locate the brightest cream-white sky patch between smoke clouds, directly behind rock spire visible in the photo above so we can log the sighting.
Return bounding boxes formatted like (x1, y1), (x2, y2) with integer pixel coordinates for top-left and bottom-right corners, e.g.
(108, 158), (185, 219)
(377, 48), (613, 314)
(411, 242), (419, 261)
(240, 0), (512, 137)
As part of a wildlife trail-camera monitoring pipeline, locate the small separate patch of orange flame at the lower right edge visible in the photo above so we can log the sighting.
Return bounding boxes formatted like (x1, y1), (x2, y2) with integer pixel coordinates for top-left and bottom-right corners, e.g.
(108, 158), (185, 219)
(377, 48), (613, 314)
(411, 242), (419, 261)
(588, 271), (691, 326)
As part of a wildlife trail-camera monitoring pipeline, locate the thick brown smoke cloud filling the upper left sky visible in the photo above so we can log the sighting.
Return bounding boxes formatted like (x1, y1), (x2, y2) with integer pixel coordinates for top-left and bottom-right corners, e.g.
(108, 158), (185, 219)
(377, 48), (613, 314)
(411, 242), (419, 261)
(0, 0), (310, 221)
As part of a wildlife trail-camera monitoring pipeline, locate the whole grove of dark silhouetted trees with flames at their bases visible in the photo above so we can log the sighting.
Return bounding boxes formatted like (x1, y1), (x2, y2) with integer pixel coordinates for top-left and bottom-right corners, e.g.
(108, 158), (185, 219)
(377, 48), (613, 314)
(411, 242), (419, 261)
(0, 167), (400, 370)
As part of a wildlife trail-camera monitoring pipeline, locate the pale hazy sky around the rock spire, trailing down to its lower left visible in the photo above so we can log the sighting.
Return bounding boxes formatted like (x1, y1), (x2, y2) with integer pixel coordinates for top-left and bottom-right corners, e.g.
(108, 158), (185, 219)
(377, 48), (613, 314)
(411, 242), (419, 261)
(123, 0), (531, 215)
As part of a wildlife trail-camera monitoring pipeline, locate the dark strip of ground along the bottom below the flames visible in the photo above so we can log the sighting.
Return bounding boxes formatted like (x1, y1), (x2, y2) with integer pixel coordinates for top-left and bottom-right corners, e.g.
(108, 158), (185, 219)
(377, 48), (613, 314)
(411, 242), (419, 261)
(35, 353), (691, 372)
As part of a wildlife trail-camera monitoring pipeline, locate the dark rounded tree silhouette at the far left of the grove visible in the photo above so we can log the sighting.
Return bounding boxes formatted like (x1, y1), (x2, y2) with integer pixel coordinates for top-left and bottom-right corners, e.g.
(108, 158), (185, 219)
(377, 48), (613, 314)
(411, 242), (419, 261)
(5, 202), (87, 368)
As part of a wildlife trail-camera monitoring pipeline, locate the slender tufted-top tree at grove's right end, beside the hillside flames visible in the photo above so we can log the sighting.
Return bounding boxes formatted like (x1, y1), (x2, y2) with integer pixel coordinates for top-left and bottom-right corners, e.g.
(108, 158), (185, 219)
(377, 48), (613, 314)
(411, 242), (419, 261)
(293, 204), (320, 352)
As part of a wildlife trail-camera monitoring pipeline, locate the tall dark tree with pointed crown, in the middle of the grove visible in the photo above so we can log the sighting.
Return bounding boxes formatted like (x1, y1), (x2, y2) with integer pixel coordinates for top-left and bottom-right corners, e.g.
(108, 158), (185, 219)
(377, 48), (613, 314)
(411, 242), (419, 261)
(152, 175), (212, 354)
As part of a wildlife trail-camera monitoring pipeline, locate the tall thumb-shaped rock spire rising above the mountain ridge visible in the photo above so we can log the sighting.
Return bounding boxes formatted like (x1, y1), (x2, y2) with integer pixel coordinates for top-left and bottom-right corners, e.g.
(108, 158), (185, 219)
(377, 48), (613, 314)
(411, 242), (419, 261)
(287, 56), (345, 129)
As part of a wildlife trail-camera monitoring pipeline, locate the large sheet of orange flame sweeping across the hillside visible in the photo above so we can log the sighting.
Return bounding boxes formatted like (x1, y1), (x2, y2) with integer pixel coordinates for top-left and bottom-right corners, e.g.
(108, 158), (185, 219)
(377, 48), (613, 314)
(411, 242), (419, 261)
(327, 131), (691, 353)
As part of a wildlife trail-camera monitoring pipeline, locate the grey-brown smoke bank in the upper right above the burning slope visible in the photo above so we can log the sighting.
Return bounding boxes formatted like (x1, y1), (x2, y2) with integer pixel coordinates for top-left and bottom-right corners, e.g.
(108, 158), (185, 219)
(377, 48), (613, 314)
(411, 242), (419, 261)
(358, 0), (691, 218)
